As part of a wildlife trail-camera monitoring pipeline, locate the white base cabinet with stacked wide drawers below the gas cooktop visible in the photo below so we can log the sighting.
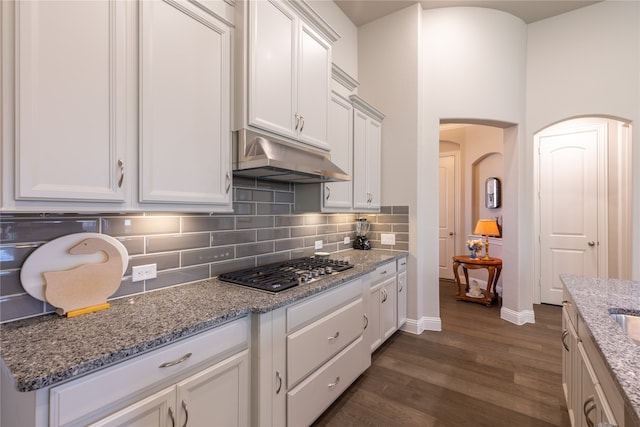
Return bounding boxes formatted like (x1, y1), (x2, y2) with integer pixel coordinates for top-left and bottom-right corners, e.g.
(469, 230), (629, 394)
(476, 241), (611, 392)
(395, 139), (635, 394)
(251, 279), (371, 427)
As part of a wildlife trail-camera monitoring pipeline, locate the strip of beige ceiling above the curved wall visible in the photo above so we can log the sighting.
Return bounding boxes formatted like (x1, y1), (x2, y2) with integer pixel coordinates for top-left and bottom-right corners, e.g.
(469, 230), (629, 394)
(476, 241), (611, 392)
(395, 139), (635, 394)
(334, 0), (598, 27)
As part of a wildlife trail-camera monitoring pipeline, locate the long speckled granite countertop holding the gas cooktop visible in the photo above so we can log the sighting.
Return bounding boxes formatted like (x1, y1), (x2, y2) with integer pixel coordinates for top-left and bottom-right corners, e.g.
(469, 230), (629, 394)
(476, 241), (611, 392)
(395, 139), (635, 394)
(0, 249), (406, 392)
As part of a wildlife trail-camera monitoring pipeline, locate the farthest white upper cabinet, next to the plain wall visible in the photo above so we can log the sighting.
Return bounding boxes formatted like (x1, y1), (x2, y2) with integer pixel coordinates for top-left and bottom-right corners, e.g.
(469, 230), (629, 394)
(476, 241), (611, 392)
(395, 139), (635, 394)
(351, 95), (384, 211)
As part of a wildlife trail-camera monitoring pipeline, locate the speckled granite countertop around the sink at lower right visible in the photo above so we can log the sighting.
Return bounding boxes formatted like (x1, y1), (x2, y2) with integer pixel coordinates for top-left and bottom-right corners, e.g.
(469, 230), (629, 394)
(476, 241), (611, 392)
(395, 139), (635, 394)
(560, 275), (640, 423)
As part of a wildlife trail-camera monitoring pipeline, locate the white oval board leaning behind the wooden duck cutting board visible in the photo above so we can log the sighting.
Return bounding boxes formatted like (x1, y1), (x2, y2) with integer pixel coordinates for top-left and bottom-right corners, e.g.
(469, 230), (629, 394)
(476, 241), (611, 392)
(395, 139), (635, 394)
(20, 233), (129, 301)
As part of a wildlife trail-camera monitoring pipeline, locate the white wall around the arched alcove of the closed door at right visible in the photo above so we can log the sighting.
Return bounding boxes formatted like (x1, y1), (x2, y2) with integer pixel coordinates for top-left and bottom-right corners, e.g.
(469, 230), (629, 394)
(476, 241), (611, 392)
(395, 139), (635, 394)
(522, 1), (640, 280)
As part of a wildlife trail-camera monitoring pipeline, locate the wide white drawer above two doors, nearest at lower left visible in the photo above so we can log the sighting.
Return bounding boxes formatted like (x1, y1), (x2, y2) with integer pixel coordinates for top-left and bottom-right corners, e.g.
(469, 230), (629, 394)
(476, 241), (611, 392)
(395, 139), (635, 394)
(49, 317), (249, 426)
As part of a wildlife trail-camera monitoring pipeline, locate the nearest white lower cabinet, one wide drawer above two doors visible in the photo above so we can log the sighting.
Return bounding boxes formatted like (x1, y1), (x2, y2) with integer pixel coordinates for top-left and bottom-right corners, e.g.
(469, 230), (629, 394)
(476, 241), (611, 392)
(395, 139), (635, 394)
(46, 318), (249, 427)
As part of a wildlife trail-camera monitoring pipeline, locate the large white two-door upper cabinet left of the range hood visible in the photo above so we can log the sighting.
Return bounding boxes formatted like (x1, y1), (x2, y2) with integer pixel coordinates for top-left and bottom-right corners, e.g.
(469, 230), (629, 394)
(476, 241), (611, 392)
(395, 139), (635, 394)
(0, 0), (234, 212)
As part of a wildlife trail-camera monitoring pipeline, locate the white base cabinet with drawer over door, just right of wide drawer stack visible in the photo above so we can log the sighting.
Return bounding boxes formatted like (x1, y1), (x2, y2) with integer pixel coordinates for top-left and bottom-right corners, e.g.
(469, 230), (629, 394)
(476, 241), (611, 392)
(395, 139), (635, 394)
(365, 261), (398, 352)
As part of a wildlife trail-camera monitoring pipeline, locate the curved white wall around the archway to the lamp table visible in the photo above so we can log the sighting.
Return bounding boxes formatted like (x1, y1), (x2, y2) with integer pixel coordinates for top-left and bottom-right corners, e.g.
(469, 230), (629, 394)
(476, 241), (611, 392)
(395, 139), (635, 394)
(422, 8), (533, 323)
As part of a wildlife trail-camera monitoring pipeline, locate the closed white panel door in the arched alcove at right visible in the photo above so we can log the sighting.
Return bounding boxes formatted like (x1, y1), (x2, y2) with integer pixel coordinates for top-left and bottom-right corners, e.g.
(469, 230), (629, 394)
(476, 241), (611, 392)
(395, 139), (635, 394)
(537, 125), (606, 304)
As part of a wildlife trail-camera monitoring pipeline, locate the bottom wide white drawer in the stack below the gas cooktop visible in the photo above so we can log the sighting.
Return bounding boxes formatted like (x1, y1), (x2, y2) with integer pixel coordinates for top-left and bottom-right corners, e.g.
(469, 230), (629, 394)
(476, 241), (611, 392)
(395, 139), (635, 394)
(287, 337), (368, 426)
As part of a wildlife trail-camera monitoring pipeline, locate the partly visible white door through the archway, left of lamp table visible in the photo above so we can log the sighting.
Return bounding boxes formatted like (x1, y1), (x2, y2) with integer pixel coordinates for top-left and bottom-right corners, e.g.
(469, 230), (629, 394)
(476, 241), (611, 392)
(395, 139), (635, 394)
(438, 155), (456, 279)
